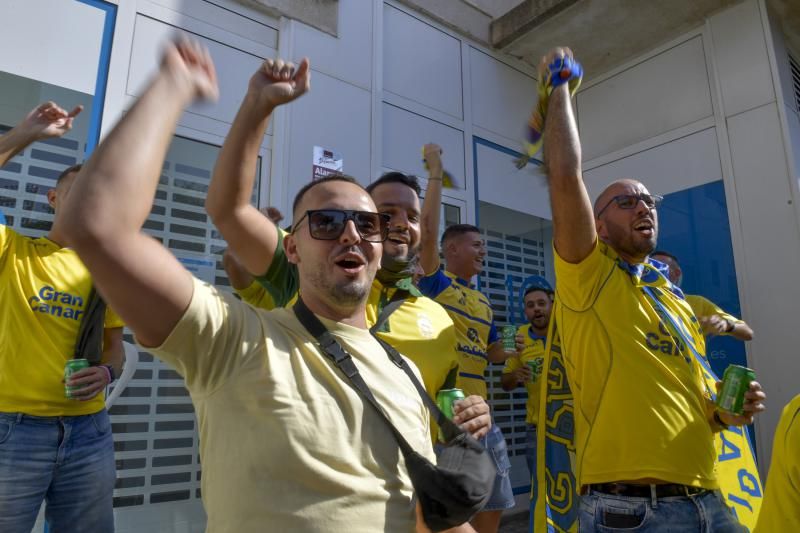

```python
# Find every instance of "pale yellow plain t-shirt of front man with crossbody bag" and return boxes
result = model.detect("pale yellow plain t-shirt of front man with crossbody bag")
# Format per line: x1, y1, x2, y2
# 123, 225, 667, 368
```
146, 280, 434, 533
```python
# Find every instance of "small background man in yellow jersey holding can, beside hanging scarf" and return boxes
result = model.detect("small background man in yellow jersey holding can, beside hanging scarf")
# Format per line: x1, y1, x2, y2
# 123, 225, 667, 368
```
500, 285, 553, 478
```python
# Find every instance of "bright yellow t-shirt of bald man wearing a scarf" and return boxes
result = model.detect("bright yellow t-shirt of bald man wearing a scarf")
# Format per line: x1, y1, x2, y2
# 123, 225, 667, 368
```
553, 243, 717, 489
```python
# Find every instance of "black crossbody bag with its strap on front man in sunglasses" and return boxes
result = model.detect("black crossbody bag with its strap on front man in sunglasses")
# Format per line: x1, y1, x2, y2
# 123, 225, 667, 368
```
293, 298, 497, 531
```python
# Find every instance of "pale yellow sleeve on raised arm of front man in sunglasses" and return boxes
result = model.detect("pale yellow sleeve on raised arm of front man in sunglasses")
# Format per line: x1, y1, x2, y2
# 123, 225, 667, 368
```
143, 278, 266, 394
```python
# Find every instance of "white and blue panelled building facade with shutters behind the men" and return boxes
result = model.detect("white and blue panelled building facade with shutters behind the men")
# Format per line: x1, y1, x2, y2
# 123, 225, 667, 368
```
0, 0, 800, 533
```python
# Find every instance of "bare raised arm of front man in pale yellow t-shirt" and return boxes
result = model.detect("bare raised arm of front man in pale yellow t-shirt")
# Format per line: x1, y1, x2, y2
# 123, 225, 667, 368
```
64, 40, 217, 346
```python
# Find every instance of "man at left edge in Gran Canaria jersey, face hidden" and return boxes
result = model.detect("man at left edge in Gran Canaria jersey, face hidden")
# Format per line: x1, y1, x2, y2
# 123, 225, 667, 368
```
0, 102, 123, 533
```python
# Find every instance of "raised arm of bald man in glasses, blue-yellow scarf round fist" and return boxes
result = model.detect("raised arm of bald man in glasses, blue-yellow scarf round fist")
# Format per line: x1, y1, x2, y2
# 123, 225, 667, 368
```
539, 48, 597, 263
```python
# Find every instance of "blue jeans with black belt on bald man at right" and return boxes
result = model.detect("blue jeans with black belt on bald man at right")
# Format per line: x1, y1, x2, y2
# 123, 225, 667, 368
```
580, 490, 747, 533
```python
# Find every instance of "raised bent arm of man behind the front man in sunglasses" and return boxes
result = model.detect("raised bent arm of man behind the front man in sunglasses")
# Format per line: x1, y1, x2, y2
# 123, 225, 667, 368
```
206, 59, 311, 275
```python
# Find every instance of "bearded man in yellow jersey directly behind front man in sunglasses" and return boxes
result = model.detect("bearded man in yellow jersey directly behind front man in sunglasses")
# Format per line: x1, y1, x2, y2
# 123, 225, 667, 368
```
206, 60, 490, 438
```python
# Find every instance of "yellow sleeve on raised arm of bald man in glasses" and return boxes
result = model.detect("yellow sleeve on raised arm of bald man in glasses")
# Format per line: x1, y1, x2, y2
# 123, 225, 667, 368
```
553, 240, 617, 311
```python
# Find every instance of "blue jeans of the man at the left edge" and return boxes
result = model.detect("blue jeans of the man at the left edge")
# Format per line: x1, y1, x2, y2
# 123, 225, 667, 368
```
0, 409, 116, 533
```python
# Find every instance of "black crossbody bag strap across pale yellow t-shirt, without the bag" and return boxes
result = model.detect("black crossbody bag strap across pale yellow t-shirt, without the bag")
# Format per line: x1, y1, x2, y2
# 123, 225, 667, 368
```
292, 297, 464, 448
